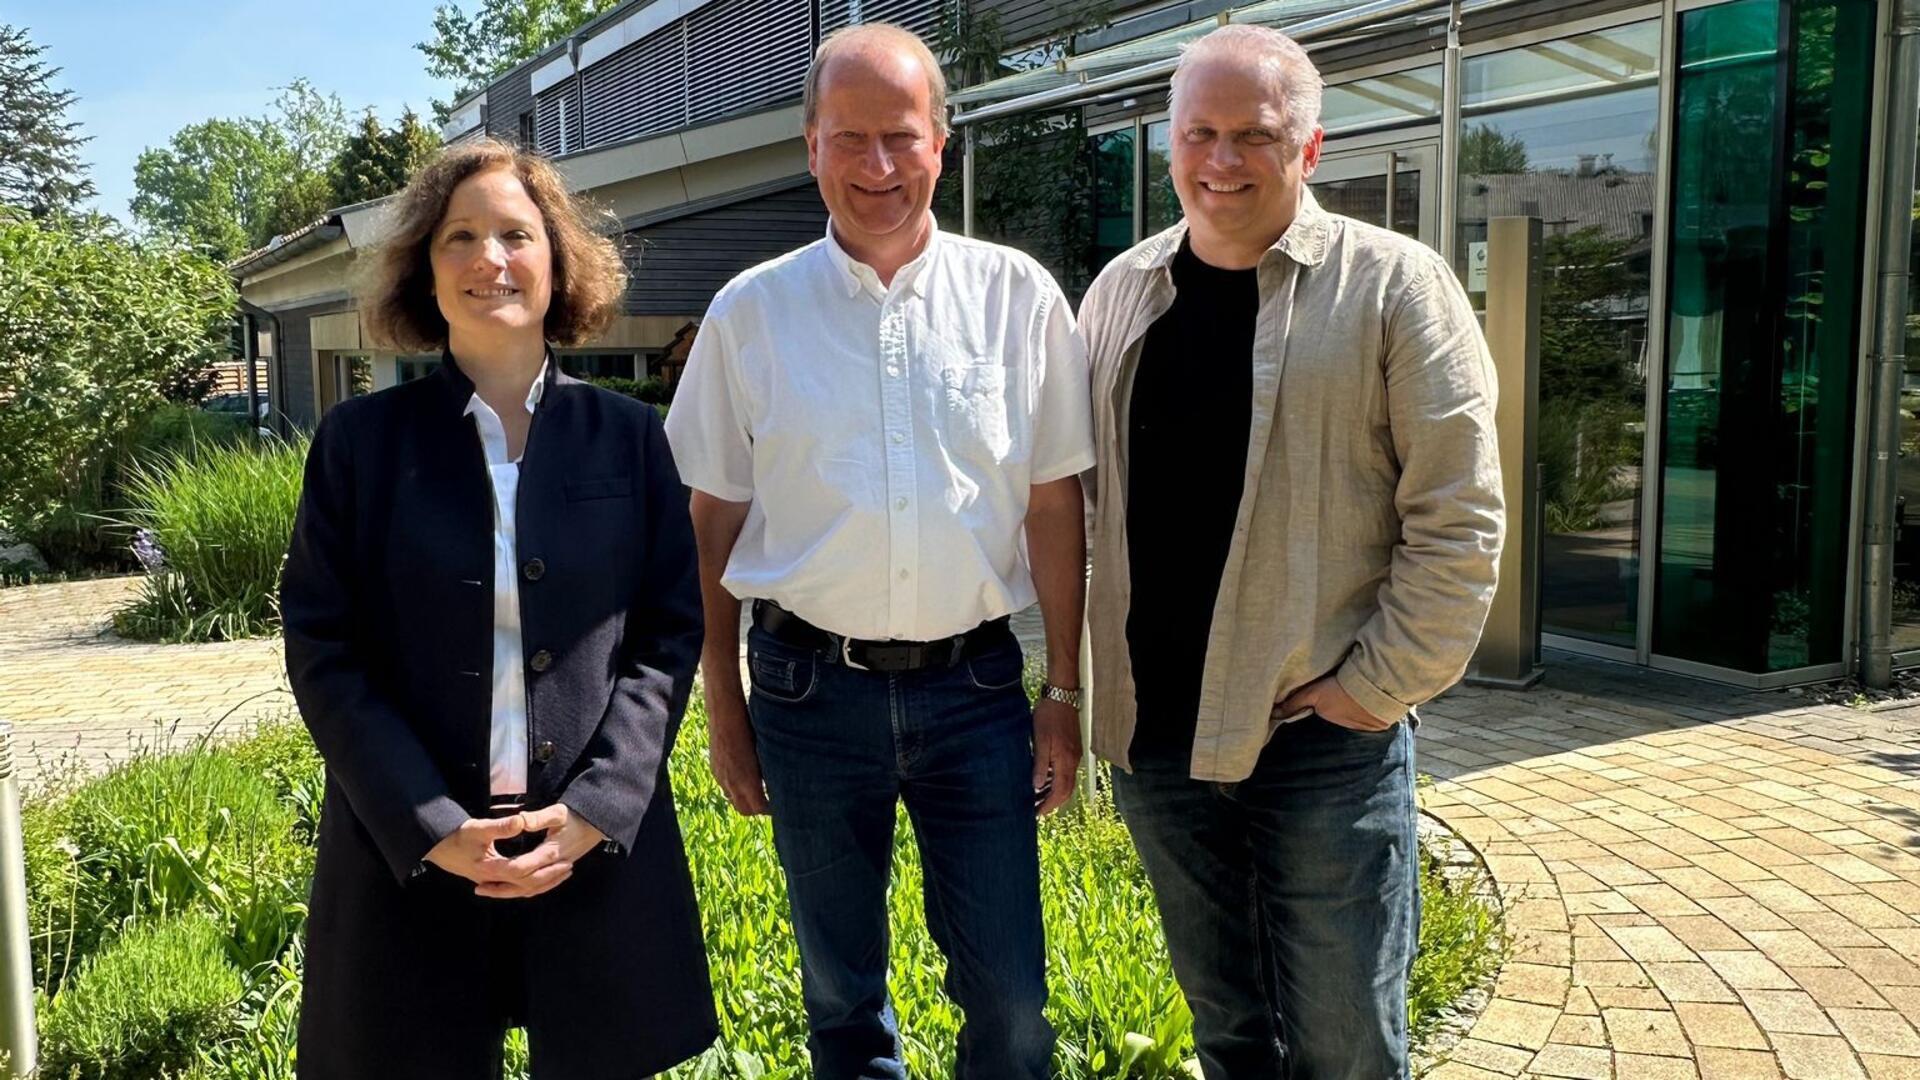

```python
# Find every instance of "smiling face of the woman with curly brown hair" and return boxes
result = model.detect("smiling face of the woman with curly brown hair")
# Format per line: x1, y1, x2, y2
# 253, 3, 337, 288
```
430, 169, 553, 344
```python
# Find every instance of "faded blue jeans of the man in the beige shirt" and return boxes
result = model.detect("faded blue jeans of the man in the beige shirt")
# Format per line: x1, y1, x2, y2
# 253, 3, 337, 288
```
1114, 717, 1419, 1080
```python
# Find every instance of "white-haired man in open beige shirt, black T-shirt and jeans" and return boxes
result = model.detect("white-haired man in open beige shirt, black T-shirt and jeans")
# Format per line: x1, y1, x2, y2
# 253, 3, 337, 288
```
1081, 27, 1505, 1080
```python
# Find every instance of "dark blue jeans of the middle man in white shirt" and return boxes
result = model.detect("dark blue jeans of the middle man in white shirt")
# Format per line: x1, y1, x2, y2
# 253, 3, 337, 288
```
747, 628, 1054, 1080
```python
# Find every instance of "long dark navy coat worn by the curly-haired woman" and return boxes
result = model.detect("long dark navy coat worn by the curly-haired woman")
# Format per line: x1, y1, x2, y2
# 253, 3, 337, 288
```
280, 357, 716, 1076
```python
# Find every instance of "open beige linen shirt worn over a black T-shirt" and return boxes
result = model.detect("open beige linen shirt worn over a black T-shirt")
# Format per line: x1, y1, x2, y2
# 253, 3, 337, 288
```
1081, 194, 1505, 782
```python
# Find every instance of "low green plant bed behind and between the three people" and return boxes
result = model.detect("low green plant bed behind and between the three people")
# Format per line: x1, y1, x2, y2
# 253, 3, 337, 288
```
25, 703, 1500, 1080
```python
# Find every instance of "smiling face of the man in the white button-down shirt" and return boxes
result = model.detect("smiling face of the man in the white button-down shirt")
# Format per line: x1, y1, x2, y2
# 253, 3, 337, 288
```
806, 42, 947, 261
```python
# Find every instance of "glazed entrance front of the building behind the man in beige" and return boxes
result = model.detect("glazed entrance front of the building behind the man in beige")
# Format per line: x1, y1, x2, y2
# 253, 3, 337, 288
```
956, 0, 1920, 686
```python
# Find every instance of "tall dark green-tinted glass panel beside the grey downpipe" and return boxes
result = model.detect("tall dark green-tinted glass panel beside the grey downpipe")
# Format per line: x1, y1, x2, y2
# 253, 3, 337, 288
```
1653, 0, 1874, 673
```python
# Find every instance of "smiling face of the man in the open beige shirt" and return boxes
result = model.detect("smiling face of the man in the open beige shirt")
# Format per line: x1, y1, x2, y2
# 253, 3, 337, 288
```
1169, 54, 1321, 258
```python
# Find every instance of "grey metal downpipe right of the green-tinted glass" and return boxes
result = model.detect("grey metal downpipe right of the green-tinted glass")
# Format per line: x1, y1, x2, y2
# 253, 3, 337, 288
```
1860, 0, 1920, 688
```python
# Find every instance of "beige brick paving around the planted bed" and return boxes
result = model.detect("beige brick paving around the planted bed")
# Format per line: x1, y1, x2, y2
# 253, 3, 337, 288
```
0, 578, 1920, 1080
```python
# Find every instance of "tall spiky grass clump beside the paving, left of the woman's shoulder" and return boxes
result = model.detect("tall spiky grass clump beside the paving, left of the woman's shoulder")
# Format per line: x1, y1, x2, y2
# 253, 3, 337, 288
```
113, 432, 307, 642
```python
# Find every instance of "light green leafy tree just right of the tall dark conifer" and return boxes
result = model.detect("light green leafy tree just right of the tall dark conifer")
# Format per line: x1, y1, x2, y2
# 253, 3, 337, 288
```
132, 79, 348, 261
